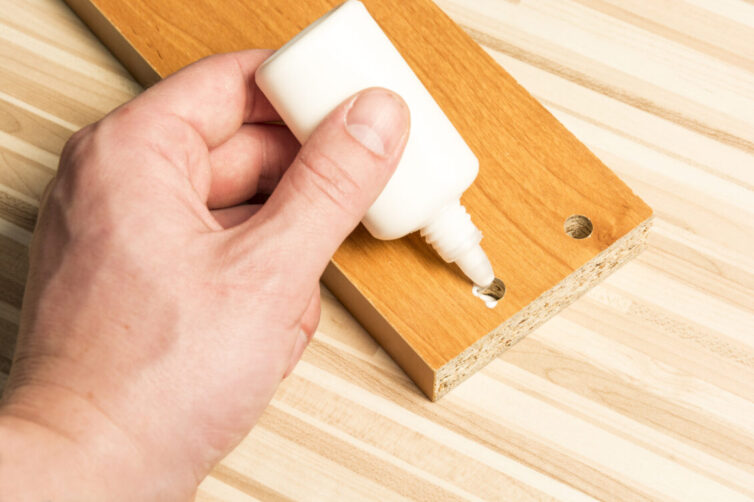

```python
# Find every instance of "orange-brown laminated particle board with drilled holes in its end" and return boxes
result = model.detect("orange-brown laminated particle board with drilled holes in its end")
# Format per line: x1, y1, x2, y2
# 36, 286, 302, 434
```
66, 0, 652, 400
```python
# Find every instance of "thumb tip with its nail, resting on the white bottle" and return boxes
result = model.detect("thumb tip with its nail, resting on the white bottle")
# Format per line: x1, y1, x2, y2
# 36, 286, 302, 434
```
346, 89, 409, 157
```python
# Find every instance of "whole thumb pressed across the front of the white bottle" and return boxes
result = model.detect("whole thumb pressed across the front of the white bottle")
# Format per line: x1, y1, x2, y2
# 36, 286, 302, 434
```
247, 88, 409, 280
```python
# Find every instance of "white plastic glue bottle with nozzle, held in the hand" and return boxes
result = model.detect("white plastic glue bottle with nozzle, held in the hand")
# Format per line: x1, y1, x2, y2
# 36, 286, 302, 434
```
256, 0, 495, 286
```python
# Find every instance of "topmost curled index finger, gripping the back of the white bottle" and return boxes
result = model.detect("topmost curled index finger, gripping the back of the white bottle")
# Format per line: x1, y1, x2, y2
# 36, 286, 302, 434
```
128, 49, 280, 148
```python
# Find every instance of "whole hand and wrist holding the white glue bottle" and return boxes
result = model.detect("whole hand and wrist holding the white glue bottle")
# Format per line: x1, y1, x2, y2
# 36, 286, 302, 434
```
0, 50, 409, 501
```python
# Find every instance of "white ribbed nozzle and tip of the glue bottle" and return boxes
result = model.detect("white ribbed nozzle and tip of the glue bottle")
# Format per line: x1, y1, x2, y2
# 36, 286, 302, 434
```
421, 201, 495, 286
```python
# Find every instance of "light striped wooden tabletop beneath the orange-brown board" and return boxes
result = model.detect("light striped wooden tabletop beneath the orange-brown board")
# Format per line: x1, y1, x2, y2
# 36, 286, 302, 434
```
0, 0, 754, 501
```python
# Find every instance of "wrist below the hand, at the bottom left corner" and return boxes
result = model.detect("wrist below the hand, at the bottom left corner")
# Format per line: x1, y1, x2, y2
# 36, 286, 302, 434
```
0, 387, 195, 501
